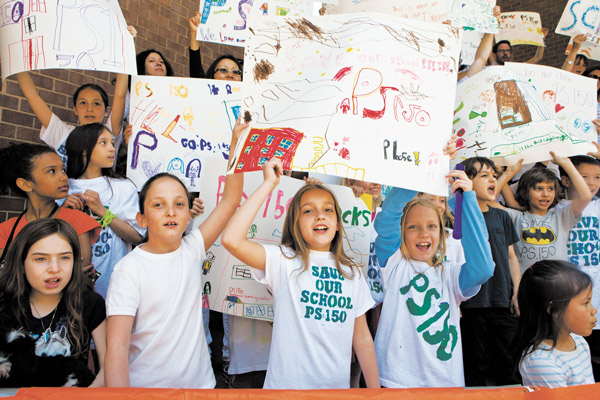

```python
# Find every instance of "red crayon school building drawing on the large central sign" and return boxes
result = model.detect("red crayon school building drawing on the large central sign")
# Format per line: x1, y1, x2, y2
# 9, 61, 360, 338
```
235, 128, 304, 172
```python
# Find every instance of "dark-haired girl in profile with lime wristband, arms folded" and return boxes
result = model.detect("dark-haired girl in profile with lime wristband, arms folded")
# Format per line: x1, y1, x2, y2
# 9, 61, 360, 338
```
63, 122, 144, 297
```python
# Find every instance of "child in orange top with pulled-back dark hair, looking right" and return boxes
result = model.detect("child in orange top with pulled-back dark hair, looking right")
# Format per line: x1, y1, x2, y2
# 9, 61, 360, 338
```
0, 143, 100, 266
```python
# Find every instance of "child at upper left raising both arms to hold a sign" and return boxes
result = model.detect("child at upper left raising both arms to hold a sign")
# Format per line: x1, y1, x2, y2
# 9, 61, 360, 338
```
17, 72, 128, 163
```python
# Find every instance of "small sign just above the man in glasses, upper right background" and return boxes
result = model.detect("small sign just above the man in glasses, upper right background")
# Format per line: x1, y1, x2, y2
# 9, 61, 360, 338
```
496, 12, 544, 46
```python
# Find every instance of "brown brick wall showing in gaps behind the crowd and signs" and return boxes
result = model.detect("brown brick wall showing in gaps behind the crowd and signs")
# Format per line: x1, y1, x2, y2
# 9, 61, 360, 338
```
0, 0, 598, 221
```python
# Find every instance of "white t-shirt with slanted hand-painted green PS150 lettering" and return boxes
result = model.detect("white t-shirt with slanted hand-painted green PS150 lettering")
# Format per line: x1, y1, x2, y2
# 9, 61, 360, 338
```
375, 250, 479, 388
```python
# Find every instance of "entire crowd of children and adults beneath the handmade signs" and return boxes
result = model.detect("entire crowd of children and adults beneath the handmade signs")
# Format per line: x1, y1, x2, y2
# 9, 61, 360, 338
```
0, 3, 600, 389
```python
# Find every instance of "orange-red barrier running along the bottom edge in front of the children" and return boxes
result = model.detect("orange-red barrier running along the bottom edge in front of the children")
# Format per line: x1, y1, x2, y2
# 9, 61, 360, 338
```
10, 383, 600, 400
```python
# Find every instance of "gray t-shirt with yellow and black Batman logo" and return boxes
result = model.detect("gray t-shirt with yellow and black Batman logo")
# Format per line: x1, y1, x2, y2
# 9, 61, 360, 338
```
506, 207, 581, 274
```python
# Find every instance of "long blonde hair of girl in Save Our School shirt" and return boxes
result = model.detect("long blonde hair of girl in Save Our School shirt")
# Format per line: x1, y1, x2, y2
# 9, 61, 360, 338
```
281, 184, 360, 279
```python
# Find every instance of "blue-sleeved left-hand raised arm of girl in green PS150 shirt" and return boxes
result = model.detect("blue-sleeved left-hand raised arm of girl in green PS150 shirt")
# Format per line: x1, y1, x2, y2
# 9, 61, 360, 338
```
375, 187, 417, 268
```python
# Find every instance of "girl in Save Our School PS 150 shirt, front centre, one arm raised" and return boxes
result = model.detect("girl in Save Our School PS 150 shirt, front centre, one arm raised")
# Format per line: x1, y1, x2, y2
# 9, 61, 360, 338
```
222, 158, 379, 389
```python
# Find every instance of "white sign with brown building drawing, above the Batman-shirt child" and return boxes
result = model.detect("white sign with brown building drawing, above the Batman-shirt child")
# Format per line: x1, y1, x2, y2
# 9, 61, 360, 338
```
454, 63, 595, 165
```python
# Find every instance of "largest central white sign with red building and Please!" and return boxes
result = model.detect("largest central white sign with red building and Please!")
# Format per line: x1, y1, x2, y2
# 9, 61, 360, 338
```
232, 13, 460, 195
